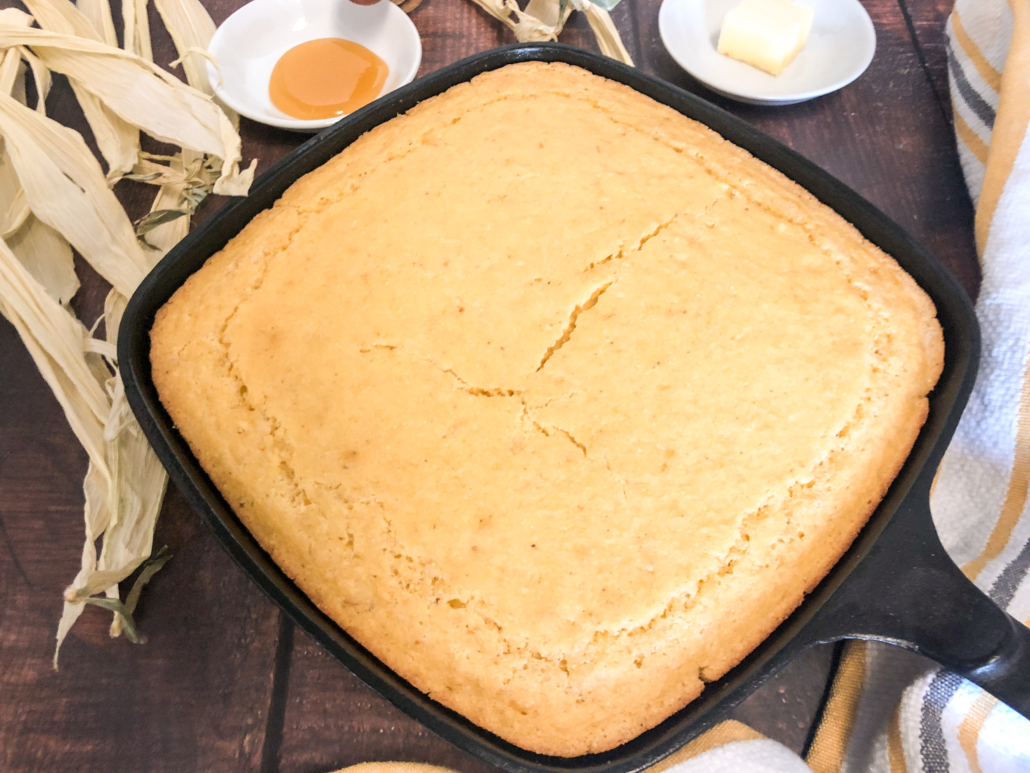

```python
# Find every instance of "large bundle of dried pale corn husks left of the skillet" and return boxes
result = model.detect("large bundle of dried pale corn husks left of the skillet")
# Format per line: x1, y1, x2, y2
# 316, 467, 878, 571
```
0, 0, 253, 667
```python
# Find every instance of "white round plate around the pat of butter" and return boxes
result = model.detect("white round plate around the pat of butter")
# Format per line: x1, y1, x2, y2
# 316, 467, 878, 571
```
658, 0, 877, 105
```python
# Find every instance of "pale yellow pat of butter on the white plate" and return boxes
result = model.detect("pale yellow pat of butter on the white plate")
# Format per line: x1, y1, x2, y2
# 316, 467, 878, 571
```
719, 0, 815, 75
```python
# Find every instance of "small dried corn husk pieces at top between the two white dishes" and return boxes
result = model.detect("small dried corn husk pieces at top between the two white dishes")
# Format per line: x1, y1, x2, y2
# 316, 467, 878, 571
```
472, 0, 633, 65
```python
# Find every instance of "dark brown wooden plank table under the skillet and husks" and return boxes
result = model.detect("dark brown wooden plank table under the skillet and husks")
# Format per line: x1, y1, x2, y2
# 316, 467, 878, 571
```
0, 0, 979, 773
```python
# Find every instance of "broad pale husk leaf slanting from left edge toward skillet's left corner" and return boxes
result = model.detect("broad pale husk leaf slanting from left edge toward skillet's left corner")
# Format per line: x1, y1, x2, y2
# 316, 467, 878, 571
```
0, 87, 150, 296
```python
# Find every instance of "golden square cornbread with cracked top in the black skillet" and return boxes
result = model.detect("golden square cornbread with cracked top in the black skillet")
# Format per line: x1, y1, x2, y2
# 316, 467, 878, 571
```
151, 63, 942, 755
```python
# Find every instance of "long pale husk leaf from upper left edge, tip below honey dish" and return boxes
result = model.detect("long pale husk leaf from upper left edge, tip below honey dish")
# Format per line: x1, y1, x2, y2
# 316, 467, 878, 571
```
0, 25, 253, 196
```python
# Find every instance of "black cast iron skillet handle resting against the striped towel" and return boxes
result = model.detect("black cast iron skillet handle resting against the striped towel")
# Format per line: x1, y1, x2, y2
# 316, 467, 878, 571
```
810, 488, 1030, 718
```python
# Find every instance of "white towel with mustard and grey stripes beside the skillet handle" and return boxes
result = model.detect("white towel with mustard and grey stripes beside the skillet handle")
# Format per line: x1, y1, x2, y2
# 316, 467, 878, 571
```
659, 0, 1030, 773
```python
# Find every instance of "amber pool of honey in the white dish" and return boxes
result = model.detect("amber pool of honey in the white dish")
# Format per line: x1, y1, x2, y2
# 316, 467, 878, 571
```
268, 37, 389, 121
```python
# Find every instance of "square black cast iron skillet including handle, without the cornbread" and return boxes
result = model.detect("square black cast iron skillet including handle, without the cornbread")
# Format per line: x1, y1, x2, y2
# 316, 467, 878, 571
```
118, 44, 1030, 773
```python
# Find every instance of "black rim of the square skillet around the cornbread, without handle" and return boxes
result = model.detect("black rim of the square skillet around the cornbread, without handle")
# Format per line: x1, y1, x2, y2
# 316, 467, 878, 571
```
118, 43, 980, 773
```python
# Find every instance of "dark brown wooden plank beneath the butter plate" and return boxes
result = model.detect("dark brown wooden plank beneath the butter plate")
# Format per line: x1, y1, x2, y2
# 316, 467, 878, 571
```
627, 0, 980, 294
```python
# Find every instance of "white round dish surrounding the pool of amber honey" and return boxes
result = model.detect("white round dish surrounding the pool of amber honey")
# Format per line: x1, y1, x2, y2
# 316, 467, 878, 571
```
207, 0, 422, 132
